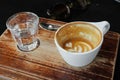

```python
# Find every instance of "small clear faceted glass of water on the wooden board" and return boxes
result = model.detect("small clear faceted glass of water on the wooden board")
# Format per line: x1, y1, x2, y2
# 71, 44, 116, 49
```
6, 12, 40, 51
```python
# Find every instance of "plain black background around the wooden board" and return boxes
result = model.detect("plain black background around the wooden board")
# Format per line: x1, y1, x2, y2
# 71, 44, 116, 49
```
0, 0, 120, 80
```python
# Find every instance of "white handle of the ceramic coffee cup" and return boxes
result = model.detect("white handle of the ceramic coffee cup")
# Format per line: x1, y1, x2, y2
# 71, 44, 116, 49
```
92, 21, 110, 35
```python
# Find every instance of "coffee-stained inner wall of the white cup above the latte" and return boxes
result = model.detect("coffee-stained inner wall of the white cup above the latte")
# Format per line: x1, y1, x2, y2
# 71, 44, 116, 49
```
55, 22, 102, 52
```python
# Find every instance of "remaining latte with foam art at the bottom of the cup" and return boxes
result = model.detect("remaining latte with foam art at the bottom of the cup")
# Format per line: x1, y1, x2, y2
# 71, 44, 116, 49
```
63, 38, 94, 52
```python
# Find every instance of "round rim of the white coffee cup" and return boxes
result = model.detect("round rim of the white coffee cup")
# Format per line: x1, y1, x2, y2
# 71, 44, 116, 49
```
54, 21, 103, 55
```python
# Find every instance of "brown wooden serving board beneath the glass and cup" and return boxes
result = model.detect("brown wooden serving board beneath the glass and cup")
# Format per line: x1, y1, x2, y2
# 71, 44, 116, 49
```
0, 18, 120, 80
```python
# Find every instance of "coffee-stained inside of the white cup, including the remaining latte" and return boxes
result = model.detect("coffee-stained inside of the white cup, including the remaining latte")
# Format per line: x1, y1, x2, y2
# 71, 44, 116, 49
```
57, 22, 102, 52
